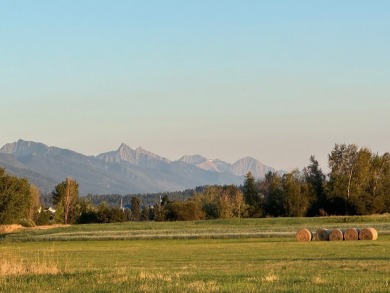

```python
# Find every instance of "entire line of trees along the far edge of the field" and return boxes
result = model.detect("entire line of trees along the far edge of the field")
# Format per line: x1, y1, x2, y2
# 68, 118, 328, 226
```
0, 144, 390, 226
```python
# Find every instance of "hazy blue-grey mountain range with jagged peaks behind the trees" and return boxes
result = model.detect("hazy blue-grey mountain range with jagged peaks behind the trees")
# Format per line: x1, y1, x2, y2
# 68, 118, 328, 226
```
0, 140, 282, 194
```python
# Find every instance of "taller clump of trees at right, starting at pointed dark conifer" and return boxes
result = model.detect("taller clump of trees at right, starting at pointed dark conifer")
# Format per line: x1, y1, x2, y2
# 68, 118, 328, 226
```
244, 144, 390, 217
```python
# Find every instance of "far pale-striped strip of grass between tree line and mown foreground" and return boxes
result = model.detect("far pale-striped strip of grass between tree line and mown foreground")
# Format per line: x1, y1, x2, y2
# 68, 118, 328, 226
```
0, 215, 390, 241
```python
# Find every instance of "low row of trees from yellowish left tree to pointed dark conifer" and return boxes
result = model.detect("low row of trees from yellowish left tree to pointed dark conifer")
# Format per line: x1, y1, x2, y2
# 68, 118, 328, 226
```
48, 184, 247, 224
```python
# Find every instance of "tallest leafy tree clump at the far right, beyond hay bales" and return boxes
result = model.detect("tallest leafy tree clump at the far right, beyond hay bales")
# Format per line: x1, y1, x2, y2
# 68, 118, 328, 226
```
328, 144, 390, 214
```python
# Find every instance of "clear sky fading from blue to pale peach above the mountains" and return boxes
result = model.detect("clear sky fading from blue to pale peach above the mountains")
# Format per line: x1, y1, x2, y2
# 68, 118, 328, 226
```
0, 0, 390, 171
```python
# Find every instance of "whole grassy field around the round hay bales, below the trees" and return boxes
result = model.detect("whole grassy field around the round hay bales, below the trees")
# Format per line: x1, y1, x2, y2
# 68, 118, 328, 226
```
0, 216, 390, 292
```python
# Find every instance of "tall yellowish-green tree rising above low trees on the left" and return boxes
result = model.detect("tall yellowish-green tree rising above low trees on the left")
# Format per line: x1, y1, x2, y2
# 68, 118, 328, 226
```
52, 177, 80, 224
